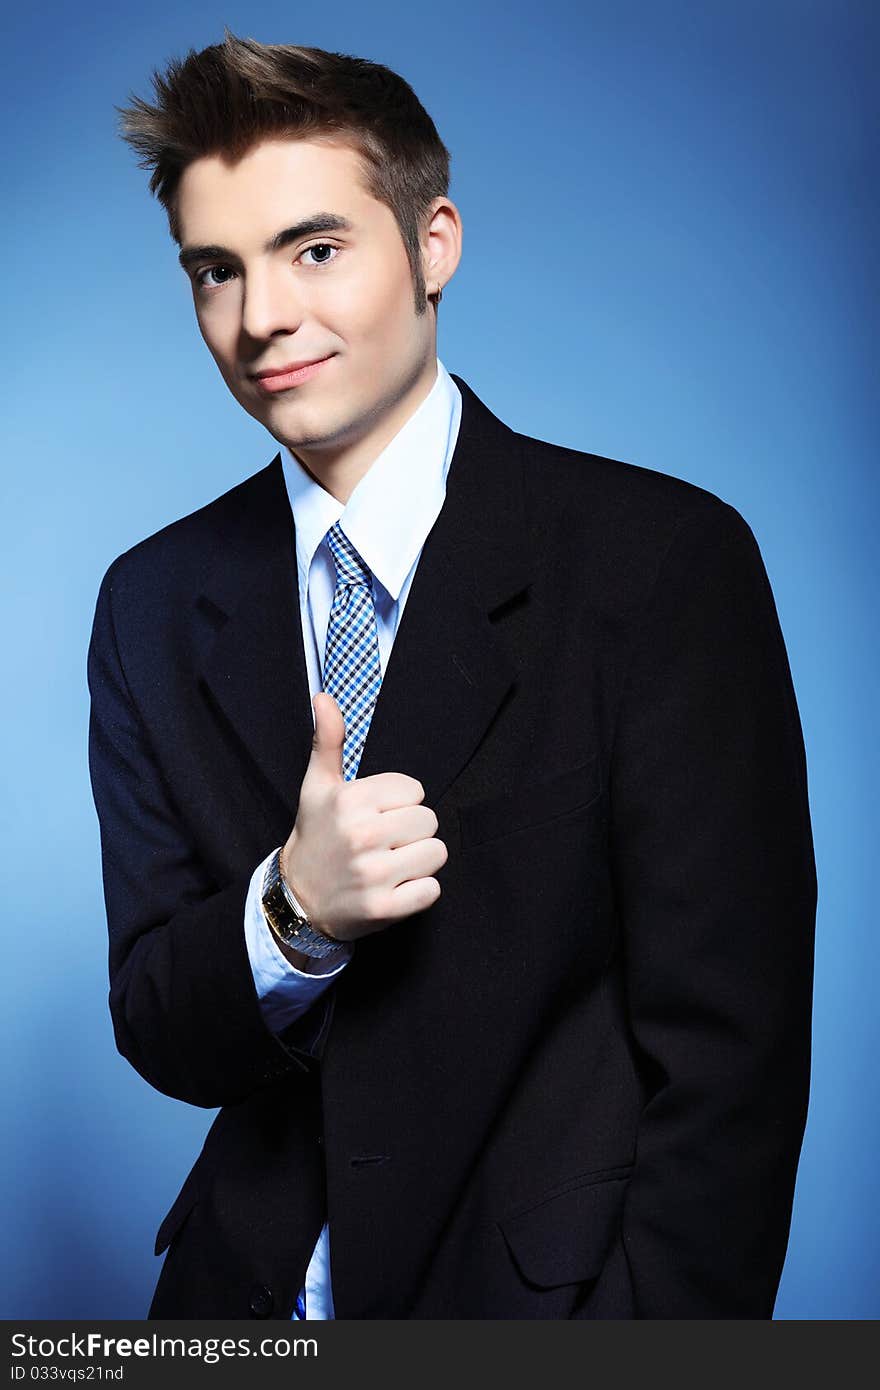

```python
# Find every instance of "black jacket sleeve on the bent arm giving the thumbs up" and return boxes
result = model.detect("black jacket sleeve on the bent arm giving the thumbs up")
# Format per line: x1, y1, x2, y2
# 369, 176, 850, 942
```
88, 560, 329, 1108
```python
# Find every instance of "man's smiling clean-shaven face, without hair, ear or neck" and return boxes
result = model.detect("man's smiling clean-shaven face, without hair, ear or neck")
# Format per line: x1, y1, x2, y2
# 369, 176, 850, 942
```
178, 139, 437, 463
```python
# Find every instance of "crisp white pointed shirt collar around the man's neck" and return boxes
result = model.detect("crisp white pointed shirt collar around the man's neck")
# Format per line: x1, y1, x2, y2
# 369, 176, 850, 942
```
281, 359, 462, 600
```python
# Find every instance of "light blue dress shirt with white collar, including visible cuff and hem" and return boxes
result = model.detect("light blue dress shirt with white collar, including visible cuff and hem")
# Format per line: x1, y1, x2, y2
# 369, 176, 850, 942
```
245, 359, 462, 1319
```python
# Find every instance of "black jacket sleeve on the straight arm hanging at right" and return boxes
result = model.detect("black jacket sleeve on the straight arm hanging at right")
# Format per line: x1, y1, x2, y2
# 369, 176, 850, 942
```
585, 503, 816, 1318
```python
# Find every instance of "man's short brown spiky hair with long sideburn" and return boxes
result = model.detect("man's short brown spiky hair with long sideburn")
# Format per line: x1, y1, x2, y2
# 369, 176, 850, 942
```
115, 25, 449, 314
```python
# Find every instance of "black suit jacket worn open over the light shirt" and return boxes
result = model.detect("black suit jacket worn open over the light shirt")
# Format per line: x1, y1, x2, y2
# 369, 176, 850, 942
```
89, 377, 816, 1318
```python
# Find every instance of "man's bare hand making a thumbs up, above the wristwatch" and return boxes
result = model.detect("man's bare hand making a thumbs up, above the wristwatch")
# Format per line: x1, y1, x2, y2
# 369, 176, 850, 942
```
281, 692, 448, 941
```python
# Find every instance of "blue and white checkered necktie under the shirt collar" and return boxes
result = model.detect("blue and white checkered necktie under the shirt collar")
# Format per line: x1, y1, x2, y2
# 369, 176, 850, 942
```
293, 521, 382, 1319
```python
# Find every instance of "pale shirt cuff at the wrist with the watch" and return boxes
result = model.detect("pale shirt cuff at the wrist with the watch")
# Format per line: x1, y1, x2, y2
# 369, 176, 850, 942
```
245, 849, 353, 1033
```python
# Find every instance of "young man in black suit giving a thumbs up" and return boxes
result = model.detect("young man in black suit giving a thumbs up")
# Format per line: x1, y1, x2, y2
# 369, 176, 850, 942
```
89, 33, 816, 1318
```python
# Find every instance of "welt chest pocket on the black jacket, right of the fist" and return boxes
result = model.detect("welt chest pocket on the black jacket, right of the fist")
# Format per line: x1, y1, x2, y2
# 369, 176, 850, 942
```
459, 753, 602, 849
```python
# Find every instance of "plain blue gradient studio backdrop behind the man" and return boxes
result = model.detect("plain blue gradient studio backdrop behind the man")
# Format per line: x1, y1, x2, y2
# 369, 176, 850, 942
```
0, 0, 880, 1319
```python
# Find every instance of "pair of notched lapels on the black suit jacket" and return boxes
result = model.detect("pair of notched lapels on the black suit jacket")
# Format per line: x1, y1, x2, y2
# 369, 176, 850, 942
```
199, 377, 530, 819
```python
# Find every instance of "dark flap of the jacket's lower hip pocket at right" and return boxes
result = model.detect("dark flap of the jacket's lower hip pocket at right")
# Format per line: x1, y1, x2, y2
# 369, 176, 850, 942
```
498, 1163, 633, 1289
